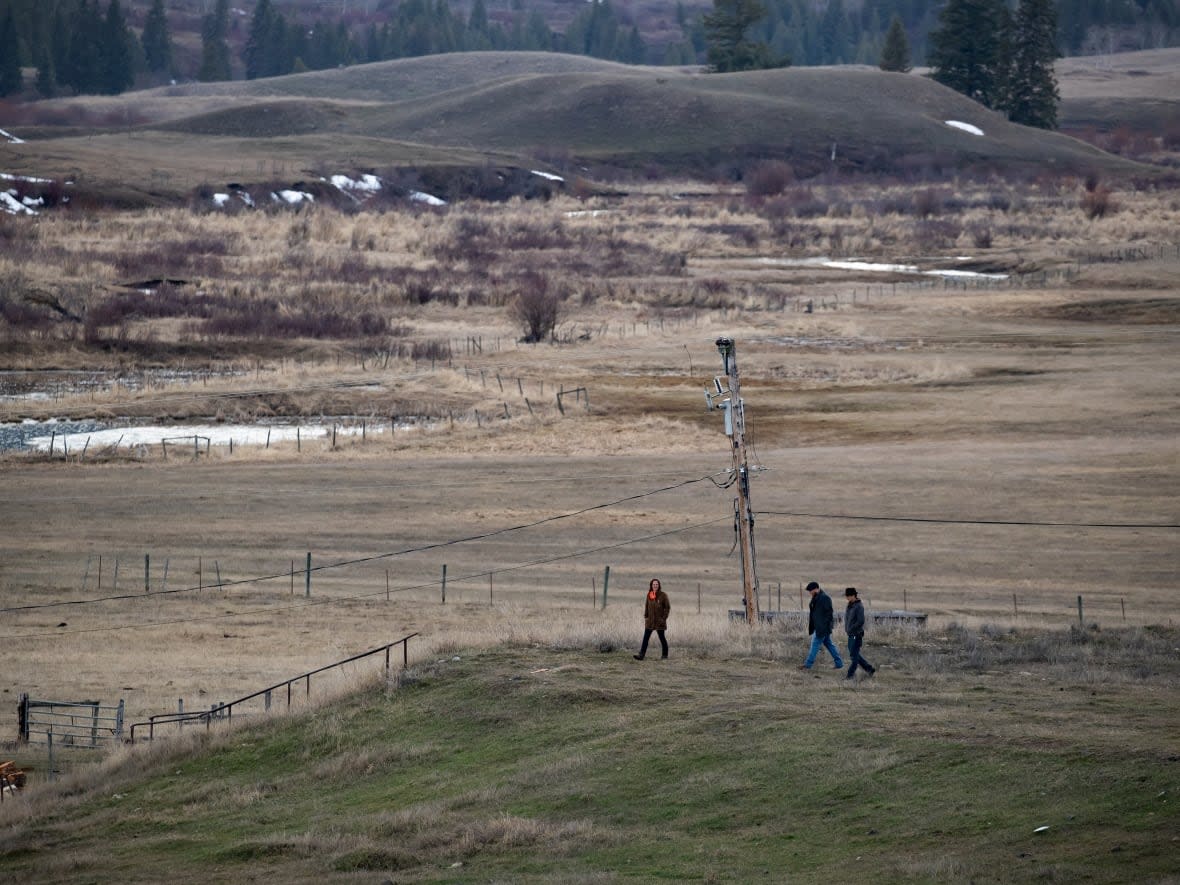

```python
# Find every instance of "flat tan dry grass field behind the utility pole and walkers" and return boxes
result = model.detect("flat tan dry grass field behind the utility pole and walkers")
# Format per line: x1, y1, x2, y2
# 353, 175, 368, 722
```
0, 182, 1180, 755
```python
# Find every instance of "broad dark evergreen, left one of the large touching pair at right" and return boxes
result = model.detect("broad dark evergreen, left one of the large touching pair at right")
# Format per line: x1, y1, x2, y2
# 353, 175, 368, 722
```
926, 0, 1007, 107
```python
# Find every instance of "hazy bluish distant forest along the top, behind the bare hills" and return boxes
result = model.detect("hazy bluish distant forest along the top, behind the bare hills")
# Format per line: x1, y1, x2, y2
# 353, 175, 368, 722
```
0, 0, 1180, 96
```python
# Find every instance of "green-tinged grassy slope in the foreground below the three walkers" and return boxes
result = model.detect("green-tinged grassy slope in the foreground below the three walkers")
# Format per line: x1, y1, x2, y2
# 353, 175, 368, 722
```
0, 628, 1180, 883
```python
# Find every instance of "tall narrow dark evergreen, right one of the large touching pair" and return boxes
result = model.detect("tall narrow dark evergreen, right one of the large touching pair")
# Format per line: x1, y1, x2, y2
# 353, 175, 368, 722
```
1004, 0, 1061, 129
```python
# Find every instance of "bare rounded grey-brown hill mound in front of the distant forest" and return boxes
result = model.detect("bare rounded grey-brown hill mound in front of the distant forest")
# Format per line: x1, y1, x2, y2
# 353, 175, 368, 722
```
0, 53, 1151, 210
